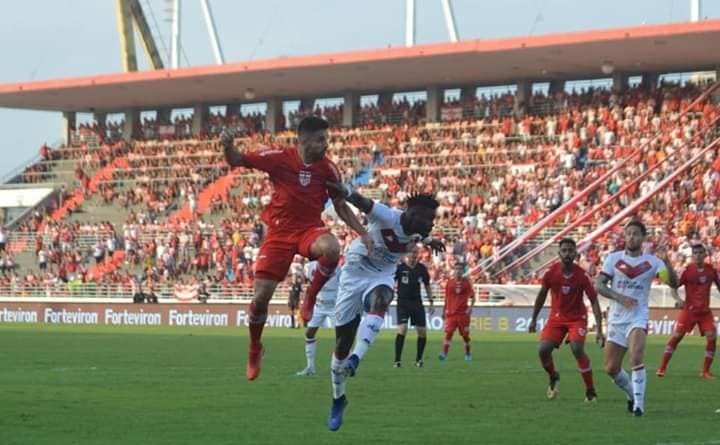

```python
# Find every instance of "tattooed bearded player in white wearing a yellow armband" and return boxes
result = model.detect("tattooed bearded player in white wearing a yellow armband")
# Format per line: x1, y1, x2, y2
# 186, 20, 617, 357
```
595, 221, 678, 416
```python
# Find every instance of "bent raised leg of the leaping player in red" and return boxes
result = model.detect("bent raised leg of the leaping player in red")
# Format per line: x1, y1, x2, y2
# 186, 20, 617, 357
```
300, 228, 340, 322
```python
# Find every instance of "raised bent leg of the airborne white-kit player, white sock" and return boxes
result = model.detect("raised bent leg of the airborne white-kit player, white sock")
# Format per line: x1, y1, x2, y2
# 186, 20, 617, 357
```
345, 285, 394, 376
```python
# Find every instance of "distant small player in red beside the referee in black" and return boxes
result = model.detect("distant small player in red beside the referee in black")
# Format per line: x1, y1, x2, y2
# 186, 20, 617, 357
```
438, 262, 475, 361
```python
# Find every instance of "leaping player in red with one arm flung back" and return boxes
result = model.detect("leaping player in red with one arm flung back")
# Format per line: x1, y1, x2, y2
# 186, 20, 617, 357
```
220, 116, 373, 380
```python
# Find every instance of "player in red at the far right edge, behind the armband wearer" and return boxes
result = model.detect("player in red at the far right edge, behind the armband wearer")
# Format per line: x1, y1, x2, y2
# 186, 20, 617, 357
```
656, 244, 720, 379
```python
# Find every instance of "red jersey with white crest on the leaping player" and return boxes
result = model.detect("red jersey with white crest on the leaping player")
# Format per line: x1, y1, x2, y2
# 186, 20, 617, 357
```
243, 148, 341, 231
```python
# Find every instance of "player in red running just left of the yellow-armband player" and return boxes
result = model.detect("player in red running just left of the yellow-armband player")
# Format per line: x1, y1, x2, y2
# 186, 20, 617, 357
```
528, 238, 605, 402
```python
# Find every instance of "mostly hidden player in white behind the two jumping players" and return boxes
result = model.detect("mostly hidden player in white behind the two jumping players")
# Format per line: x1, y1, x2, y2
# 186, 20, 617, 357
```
295, 261, 341, 376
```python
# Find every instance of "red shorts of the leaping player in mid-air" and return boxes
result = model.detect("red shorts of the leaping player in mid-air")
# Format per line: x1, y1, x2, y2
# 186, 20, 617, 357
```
255, 227, 330, 281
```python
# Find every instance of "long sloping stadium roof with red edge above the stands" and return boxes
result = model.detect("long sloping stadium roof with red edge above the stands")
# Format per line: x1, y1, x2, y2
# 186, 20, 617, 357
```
0, 20, 720, 111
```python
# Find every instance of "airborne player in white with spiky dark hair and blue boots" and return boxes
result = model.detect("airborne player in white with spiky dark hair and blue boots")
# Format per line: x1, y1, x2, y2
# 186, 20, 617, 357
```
328, 183, 445, 431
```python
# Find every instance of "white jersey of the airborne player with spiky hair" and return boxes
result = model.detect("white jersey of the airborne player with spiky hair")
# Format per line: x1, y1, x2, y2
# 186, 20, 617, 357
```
345, 202, 422, 276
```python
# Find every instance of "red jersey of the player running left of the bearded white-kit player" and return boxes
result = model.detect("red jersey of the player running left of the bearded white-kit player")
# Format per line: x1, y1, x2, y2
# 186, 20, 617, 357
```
542, 263, 597, 320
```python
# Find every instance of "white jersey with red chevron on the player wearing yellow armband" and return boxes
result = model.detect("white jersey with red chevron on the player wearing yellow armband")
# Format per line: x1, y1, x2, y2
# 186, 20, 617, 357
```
601, 251, 666, 323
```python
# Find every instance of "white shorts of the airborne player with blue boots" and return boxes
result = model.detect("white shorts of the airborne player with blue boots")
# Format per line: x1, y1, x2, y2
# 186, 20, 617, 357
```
335, 265, 395, 326
